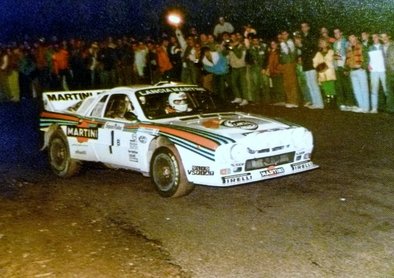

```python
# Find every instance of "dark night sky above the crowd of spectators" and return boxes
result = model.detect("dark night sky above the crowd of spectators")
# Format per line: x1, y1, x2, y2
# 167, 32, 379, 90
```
0, 0, 394, 42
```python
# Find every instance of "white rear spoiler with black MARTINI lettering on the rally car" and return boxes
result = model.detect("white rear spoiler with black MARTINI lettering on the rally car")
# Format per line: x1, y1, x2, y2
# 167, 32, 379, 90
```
42, 90, 108, 112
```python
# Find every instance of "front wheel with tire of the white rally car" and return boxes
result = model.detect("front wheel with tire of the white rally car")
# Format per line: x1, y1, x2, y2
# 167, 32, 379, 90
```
150, 146, 194, 198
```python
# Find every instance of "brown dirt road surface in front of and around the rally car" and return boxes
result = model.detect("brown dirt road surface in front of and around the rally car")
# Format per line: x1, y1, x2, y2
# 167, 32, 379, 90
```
0, 103, 394, 277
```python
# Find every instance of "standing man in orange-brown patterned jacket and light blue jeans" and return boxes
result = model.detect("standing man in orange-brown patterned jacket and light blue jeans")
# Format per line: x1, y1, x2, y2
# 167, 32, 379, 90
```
346, 34, 369, 113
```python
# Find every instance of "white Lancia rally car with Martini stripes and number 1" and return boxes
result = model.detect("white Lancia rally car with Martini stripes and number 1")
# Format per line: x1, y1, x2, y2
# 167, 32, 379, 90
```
40, 83, 318, 197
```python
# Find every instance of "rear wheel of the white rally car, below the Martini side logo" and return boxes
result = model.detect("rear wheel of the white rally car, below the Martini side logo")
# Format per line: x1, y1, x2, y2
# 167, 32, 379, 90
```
48, 130, 81, 178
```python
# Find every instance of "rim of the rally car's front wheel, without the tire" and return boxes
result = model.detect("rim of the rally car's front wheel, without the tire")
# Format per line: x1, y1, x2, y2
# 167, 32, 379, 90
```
153, 154, 176, 191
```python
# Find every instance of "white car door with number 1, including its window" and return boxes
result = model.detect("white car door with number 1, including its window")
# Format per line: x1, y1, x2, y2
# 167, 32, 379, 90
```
93, 93, 139, 169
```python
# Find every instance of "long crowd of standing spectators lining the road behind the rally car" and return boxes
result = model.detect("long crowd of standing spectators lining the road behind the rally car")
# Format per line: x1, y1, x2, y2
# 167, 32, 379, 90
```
0, 17, 394, 113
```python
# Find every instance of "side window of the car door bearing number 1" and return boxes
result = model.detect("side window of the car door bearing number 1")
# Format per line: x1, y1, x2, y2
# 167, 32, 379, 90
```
104, 94, 134, 120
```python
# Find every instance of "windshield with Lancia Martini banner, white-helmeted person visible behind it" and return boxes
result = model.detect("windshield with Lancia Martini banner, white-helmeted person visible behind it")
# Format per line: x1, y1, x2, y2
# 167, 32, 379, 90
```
137, 86, 225, 119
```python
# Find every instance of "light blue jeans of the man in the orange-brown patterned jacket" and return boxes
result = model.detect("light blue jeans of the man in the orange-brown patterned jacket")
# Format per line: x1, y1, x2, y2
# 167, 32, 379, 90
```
350, 69, 369, 111
